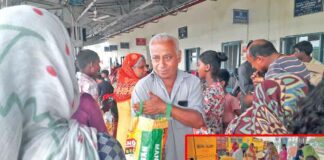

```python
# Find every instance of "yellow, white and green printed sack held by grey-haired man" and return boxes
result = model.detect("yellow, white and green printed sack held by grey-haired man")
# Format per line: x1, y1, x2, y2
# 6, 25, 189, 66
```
125, 103, 170, 160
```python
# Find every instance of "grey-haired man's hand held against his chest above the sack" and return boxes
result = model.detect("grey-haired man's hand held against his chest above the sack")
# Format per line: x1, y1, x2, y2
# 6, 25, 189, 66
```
133, 92, 166, 115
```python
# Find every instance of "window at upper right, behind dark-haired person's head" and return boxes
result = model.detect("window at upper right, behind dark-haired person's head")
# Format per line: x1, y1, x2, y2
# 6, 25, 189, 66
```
280, 33, 324, 62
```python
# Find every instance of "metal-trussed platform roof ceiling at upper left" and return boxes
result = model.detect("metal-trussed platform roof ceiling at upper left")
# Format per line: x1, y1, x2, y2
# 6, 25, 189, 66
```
0, 0, 204, 45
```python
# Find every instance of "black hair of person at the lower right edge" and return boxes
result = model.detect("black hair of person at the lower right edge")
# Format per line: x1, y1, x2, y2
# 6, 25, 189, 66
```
289, 80, 324, 134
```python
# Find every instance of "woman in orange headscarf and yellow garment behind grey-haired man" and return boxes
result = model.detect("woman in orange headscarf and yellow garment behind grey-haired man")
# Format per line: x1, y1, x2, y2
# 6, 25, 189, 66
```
114, 53, 147, 150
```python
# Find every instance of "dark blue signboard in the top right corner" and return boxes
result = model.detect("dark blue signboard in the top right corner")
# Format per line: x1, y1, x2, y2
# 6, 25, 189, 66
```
294, 0, 323, 17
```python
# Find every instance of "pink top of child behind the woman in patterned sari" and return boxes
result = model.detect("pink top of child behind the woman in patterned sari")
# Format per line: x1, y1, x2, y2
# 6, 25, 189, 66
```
223, 93, 241, 124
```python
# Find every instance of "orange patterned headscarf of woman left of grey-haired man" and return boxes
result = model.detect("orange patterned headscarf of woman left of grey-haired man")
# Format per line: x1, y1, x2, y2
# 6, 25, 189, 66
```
115, 53, 143, 102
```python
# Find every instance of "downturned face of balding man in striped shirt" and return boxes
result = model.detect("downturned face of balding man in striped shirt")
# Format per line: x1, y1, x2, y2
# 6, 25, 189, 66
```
246, 53, 268, 73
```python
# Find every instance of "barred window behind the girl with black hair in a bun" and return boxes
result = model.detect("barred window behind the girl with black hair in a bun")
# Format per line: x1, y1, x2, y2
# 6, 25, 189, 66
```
222, 41, 241, 71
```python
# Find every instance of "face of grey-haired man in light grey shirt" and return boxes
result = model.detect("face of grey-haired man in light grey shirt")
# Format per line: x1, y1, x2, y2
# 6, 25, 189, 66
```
150, 40, 181, 79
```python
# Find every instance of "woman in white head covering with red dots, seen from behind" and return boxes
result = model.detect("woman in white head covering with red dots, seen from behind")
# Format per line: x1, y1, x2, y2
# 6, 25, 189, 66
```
0, 6, 124, 160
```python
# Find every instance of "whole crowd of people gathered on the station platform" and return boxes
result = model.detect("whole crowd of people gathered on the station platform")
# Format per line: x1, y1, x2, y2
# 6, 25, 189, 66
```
0, 6, 324, 159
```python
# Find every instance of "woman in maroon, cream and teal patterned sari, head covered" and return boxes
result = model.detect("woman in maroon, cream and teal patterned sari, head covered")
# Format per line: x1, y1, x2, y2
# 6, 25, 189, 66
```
226, 73, 308, 134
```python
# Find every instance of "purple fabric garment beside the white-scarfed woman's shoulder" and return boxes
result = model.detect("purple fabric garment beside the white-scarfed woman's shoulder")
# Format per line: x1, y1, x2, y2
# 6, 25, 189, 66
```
72, 93, 107, 133
